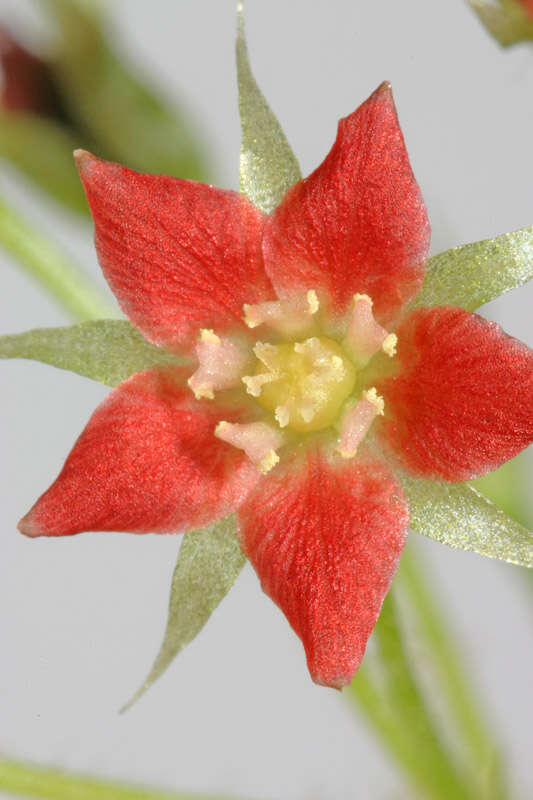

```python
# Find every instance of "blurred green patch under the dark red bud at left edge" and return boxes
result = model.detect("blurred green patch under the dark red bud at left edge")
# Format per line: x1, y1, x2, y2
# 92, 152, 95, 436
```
0, 111, 89, 215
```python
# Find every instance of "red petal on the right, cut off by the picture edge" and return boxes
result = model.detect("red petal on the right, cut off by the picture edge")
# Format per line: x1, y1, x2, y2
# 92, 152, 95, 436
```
377, 306, 533, 481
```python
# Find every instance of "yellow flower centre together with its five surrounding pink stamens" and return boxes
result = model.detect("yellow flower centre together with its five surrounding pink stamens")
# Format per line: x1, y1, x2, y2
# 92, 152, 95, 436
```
201, 289, 397, 472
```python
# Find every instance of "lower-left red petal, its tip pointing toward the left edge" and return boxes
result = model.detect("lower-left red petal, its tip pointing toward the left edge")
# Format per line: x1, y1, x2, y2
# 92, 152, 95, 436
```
19, 370, 259, 536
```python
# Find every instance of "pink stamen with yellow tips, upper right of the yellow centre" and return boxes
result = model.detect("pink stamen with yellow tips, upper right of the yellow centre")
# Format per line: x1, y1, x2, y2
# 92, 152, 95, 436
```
344, 294, 398, 369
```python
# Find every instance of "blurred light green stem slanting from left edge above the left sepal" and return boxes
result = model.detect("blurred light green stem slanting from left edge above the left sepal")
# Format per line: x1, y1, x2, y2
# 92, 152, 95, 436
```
0, 198, 118, 320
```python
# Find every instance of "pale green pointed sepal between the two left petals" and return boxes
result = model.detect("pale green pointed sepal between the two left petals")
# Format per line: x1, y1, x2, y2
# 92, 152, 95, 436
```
0, 319, 183, 386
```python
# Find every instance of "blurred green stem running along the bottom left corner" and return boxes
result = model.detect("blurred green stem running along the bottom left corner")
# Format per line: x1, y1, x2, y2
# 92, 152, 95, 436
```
0, 758, 235, 800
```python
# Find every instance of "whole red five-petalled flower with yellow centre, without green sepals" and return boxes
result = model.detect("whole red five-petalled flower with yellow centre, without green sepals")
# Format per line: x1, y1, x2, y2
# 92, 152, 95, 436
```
16, 84, 533, 687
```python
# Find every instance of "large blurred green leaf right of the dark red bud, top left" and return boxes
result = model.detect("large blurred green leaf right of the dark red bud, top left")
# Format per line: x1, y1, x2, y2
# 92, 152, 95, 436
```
40, 0, 207, 180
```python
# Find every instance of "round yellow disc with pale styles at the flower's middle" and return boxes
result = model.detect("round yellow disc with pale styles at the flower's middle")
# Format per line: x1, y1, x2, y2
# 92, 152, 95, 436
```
253, 336, 355, 432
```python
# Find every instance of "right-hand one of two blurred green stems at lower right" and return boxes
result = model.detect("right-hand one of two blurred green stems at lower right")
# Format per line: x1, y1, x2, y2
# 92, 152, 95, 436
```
397, 549, 507, 799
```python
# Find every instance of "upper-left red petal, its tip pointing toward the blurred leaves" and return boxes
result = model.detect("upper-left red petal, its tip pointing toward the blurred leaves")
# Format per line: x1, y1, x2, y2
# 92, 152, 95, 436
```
78, 151, 274, 349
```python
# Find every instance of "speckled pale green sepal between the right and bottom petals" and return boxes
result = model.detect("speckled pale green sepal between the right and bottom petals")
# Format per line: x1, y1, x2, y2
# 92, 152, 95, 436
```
402, 475, 533, 567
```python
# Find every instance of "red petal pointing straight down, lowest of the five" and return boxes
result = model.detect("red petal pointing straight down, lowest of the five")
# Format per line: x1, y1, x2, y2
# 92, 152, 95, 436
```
239, 451, 409, 689
